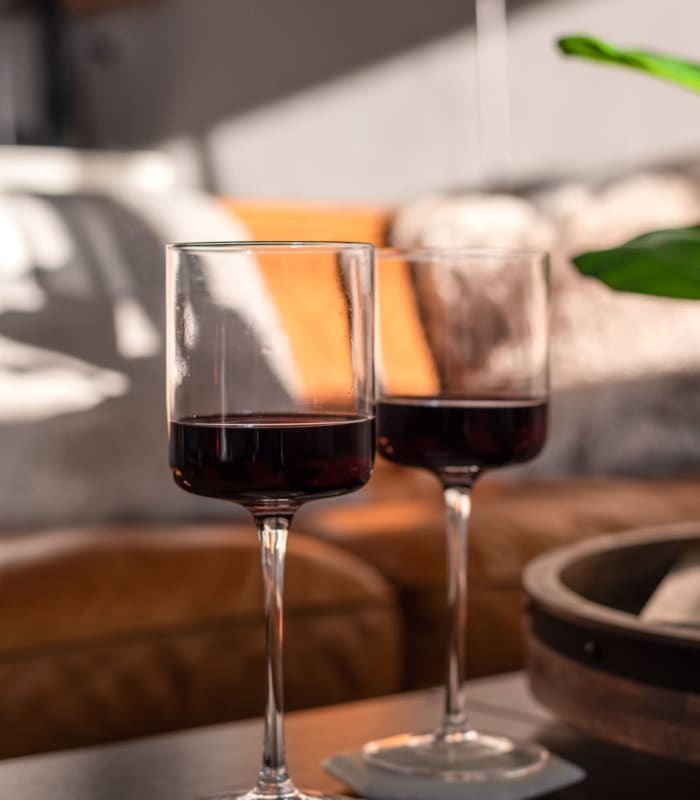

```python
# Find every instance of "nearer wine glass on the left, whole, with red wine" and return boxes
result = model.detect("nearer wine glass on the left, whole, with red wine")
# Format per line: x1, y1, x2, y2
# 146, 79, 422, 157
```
167, 242, 374, 800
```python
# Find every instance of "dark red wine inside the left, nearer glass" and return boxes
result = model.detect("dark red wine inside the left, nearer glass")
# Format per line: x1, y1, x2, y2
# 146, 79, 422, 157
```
170, 414, 374, 507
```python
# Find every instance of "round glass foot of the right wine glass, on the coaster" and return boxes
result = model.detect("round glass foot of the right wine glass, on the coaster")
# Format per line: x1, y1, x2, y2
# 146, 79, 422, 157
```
362, 731, 549, 783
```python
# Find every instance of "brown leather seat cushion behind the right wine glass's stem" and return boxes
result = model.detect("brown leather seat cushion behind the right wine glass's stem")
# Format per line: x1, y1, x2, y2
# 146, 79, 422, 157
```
304, 466, 700, 688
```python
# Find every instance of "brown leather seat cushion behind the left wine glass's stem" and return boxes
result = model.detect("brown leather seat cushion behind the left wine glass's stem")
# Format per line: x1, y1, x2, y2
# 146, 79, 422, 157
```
0, 525, 402, 757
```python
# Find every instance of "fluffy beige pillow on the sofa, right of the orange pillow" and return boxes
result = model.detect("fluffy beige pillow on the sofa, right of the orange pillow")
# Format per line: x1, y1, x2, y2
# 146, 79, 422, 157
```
392, 170, 700, 477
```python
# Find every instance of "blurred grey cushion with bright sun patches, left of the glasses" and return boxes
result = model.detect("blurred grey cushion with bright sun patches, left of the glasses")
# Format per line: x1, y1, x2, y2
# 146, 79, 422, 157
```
0, 184, 264, 531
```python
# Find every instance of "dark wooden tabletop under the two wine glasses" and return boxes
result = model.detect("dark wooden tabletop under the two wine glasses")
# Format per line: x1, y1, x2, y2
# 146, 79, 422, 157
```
0, 675, 700, 800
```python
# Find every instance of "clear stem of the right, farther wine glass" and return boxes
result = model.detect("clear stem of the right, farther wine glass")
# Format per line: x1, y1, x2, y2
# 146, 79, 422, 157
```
439, 485, 471, 737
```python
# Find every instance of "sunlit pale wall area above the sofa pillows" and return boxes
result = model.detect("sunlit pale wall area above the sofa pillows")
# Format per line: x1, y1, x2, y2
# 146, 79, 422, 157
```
205, 0, 700, 202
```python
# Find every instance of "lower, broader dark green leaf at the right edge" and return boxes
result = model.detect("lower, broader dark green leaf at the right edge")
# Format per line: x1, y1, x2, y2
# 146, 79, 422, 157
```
574, 225, 700, 300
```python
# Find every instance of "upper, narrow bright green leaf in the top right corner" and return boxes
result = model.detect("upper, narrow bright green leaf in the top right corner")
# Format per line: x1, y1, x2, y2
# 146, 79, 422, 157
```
557, 36, 700, 92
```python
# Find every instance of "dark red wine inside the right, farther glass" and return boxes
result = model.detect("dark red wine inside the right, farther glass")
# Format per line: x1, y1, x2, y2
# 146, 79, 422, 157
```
377, 397, 547, 472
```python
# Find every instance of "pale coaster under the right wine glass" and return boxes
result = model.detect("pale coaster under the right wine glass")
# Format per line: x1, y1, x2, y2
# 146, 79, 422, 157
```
323, 750, 586, 800
